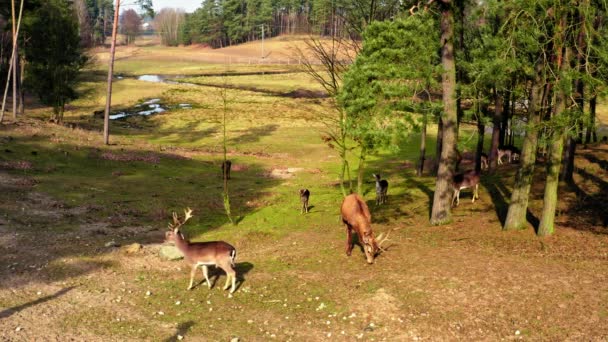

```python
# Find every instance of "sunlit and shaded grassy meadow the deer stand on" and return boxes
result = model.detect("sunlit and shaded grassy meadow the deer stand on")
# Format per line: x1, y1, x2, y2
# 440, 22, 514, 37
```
0, 39, 608, 341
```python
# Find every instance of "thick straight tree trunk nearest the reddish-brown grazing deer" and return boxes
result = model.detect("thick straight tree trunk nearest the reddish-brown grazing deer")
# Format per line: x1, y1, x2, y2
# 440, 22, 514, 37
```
430, 2, 458, 225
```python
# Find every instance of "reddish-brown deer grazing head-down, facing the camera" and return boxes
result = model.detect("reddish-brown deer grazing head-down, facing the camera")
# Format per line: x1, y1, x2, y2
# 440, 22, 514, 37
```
340, 194, 390, 264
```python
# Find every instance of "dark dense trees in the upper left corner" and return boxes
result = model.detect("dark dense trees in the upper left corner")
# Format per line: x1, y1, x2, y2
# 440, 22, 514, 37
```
0, 0, 87, 121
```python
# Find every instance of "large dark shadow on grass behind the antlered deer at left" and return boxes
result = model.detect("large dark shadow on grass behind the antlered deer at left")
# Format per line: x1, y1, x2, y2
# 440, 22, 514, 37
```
0, 126, 282, 288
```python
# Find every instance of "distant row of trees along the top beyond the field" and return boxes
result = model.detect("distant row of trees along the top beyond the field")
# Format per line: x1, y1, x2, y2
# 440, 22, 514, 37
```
180, 0, 400, 47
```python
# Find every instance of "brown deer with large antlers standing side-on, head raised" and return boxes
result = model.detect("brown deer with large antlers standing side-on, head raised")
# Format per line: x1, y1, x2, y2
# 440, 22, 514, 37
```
165, 208, 236, 294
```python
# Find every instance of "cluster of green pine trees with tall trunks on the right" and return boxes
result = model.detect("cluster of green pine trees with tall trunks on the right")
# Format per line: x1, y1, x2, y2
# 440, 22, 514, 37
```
316, 0, 608, 235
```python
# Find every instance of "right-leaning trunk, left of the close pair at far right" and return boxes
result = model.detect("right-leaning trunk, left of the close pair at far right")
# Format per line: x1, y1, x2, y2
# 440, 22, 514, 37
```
503, 60, 545, 230
